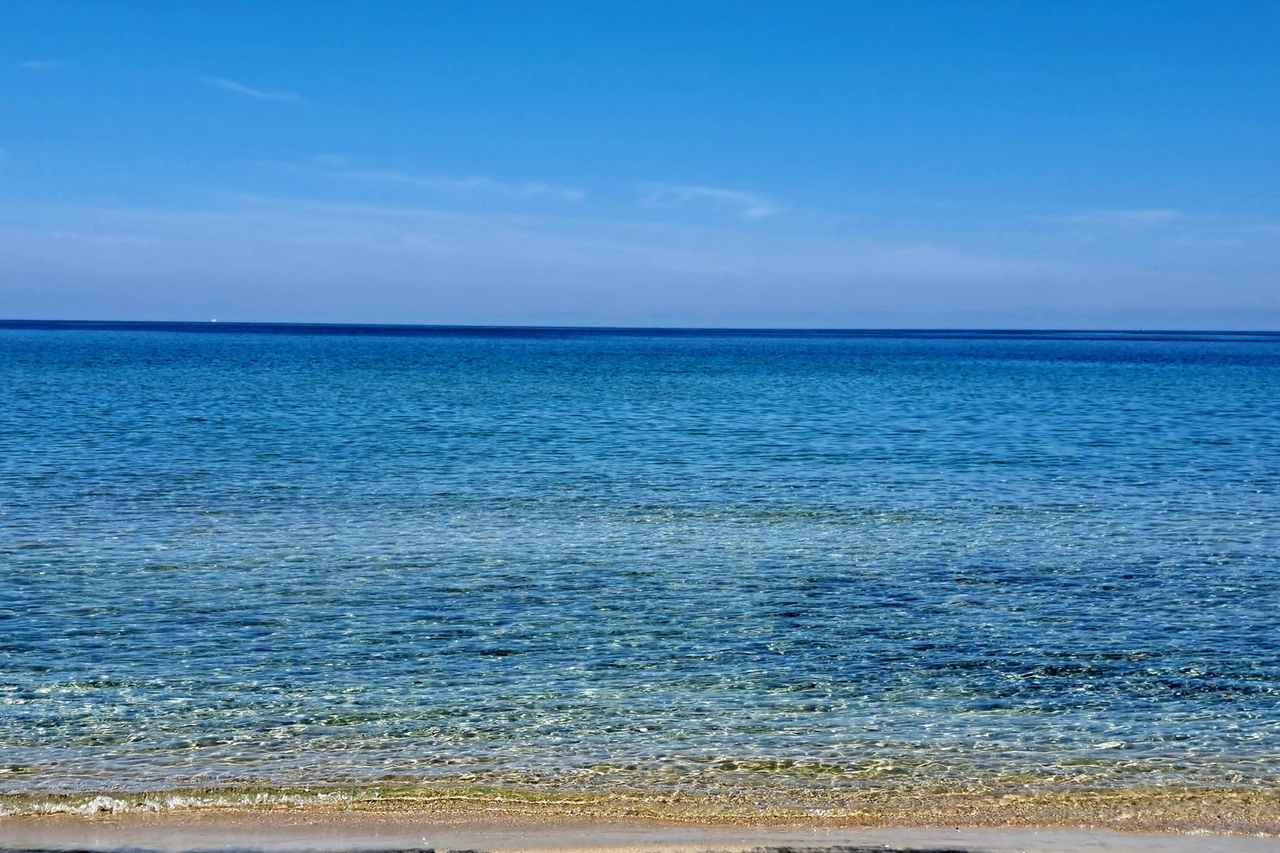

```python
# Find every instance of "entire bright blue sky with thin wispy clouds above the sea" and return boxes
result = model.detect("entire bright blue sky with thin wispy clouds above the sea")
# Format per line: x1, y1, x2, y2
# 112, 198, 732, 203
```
0, 0, 1280, 329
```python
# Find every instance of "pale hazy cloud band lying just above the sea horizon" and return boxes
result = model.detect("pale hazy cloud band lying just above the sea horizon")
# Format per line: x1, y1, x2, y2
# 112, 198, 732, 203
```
17, 196, 1280, 327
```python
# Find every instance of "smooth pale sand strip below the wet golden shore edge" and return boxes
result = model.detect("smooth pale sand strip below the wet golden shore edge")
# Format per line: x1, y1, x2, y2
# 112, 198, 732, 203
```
0, 812, 1280, 853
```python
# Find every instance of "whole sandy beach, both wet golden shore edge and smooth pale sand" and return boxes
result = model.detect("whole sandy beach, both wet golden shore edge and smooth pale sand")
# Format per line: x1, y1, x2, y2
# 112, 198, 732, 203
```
0, 788, 1280, 853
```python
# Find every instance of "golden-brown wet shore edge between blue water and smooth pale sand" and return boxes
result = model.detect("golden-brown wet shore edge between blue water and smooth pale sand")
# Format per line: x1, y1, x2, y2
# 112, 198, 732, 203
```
0, 784, 1280, 835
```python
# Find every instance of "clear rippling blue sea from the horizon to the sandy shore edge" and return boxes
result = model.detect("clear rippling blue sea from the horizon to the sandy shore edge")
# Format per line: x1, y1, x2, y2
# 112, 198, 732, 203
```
0, 324, 1280, 793
